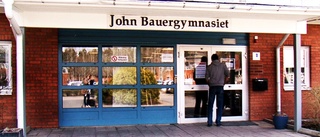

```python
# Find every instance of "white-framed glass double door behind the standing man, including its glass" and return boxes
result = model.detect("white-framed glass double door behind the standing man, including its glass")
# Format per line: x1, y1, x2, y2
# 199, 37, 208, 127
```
178, 45, 248, 123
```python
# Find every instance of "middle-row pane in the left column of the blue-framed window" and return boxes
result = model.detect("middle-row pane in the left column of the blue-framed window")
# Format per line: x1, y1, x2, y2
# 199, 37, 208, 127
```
62, 67, 99, 86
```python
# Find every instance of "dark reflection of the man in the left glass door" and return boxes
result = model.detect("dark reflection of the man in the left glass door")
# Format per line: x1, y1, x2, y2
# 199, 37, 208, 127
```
193, 56, 208, 117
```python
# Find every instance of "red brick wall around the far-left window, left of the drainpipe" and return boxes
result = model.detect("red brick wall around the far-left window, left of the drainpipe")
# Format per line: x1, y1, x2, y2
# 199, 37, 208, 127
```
0, 14, 17, 129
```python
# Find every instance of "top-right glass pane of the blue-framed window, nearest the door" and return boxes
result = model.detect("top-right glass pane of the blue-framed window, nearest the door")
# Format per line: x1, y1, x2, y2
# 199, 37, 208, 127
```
141, 47, 173, 63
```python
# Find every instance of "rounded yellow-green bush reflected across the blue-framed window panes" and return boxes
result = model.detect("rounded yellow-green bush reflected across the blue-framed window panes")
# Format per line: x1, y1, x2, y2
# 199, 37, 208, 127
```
103, 67, 160, 105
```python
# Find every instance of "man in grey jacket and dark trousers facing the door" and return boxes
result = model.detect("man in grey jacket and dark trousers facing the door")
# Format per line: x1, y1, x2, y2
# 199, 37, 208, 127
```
205, 54, 229, 127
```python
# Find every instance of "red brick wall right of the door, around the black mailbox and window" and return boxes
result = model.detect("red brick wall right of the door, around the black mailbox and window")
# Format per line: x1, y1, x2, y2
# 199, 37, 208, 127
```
249, 25, 320, 120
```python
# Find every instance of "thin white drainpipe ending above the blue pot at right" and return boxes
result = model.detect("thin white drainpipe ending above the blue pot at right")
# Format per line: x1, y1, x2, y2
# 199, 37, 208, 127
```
276, 34, 290, 114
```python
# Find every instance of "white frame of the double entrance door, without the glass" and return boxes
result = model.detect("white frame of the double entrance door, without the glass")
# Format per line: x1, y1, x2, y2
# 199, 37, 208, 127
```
177, 44, 249, 123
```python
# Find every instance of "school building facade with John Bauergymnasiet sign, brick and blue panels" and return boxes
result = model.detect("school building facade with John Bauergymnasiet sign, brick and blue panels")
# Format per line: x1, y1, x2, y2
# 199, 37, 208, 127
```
0, 0, 320, 135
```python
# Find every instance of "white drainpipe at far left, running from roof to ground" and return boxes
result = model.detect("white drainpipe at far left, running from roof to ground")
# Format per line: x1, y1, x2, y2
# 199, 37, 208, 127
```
2, 0, 27, 137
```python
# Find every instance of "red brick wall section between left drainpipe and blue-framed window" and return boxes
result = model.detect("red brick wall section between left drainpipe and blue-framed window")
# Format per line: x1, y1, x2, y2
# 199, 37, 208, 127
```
25, 28, 59, 128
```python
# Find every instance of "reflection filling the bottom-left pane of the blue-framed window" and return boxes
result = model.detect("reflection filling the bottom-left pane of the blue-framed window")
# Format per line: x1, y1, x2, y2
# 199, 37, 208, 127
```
62, 89, 98, 108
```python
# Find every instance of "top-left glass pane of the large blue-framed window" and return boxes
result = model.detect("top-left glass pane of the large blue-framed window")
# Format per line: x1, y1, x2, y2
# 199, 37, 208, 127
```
62, 47, 98, 62
